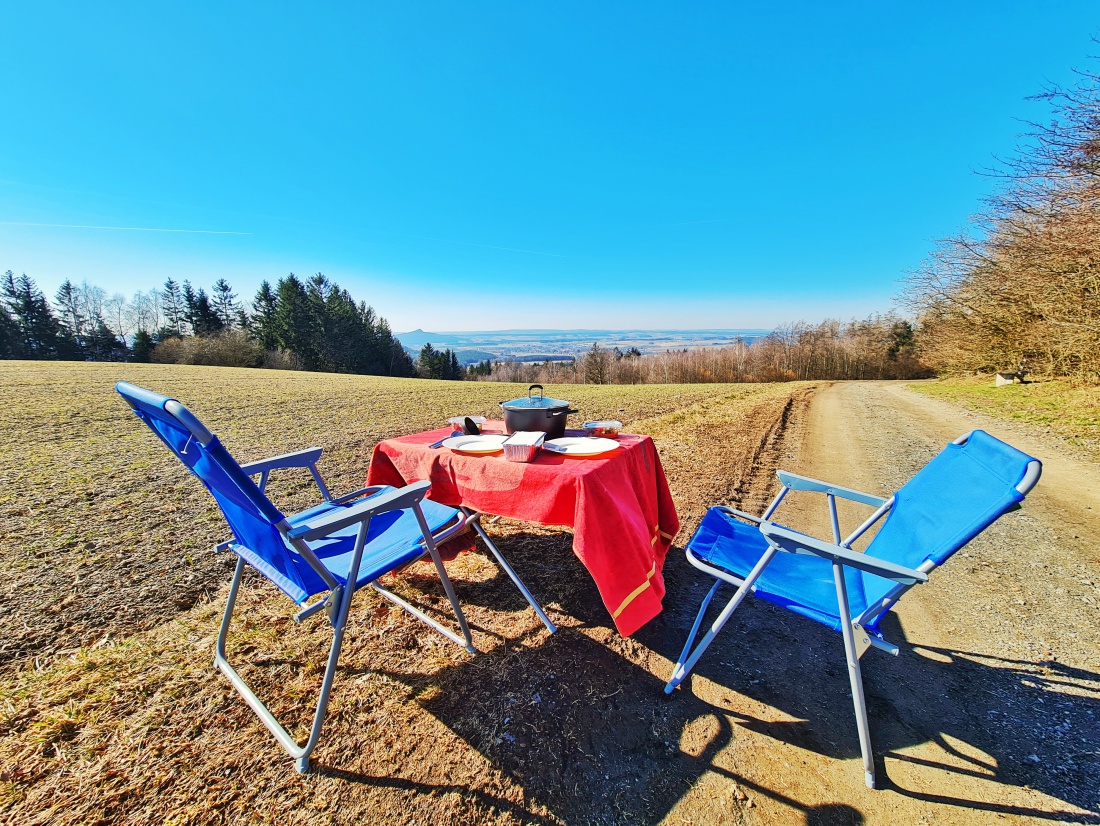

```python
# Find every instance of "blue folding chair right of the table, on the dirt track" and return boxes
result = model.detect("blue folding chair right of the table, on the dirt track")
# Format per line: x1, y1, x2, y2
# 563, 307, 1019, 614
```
664, 430, 1043, 789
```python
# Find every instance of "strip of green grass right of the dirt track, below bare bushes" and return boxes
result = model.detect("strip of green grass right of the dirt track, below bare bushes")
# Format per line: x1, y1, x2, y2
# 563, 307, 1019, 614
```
910, 376, 1100, 460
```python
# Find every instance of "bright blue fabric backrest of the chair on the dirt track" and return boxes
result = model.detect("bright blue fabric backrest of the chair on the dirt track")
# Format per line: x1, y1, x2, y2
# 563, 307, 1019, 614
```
865, 430, 1042, 604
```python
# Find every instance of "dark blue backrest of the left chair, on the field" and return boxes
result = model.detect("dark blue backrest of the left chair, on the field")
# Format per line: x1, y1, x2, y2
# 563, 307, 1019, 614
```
114, 382, 303, 592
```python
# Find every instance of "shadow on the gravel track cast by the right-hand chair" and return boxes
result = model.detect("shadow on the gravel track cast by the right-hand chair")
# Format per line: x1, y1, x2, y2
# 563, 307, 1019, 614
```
638, 549, 1100, 824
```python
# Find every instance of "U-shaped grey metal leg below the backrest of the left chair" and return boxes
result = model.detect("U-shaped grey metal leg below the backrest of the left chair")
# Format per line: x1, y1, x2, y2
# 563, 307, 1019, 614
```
215, 558, 354, 773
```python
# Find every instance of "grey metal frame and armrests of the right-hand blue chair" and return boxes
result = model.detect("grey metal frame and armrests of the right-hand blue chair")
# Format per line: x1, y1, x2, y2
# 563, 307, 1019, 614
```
664, 433, 1042, 789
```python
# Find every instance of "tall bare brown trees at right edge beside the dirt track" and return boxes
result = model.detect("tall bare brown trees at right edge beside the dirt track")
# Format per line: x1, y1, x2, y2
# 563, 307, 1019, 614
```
904, 58, 1100, 382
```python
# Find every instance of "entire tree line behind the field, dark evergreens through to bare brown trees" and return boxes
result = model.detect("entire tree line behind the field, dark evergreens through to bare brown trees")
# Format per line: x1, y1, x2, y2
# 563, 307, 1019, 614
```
0, 271, 933, 384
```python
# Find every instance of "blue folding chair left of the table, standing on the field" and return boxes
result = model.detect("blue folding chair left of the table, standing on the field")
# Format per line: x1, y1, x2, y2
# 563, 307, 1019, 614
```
116, 382, 486, 772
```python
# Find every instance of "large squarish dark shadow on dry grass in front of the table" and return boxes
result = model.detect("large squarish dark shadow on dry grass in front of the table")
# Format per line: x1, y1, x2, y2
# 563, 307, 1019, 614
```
326, 627, 733, 824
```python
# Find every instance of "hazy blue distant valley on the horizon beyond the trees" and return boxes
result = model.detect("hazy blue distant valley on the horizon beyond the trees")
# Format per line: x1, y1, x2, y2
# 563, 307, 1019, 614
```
395, 329, 771, 364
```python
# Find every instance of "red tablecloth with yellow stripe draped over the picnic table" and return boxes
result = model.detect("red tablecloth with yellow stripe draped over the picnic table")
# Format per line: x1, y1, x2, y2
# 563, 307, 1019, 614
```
366, 421, 680, 637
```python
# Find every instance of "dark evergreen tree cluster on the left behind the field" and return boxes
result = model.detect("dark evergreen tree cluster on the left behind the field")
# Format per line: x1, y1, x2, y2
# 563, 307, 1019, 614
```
0, 271, 418, 376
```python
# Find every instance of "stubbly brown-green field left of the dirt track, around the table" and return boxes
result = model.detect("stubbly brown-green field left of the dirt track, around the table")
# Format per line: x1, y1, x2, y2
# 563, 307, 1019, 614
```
0, 362, 813, 824
